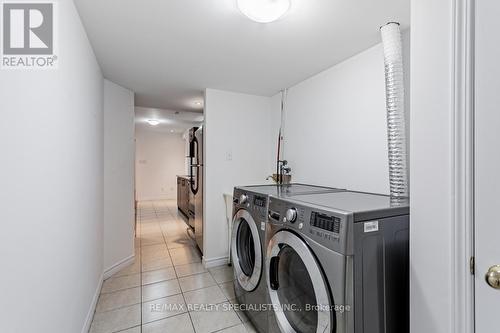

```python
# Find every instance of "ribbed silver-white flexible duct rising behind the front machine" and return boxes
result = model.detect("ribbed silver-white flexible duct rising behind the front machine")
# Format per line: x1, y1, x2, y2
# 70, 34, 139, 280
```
380, 22, 408, 197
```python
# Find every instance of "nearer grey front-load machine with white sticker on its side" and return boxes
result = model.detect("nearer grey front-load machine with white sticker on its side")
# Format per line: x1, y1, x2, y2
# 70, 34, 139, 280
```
264, 191, 409, 333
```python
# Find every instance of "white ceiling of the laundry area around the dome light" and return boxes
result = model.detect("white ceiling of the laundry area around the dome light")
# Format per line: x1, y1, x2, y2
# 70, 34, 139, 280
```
75, 0, 410, 111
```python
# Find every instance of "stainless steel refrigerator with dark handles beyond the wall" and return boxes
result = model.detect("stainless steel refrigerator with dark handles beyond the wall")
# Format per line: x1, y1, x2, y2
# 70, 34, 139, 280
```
188, 127, 203, 252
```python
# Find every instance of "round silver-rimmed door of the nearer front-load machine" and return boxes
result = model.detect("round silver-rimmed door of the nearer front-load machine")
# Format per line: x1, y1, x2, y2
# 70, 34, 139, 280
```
266, 231, 335, 333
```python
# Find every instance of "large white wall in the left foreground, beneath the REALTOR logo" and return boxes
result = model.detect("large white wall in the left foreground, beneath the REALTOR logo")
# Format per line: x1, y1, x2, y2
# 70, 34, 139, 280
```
0, 1, 103, 333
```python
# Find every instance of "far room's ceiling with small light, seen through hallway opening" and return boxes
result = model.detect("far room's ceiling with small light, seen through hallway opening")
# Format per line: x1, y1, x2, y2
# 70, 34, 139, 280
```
135, 107, 203, 133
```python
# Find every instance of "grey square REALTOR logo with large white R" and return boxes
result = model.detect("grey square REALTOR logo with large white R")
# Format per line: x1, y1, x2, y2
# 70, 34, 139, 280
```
1, 1, 57, 69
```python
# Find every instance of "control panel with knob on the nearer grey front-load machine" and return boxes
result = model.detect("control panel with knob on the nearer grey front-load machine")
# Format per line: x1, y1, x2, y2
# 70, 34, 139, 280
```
268, 198, 349, 253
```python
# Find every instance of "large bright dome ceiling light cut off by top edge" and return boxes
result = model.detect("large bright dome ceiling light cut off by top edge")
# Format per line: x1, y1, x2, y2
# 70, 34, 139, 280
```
237, 0, 290, 23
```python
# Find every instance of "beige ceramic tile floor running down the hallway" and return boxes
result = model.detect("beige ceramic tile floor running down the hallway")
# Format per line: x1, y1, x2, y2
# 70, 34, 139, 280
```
90, 200, 255, 333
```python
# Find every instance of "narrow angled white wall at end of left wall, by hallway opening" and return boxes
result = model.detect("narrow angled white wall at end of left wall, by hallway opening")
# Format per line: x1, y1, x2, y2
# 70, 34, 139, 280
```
104, 80, 135, 275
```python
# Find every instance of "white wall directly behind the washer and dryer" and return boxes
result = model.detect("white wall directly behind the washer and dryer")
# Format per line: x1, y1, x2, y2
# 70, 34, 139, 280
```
271, 32, 409, 193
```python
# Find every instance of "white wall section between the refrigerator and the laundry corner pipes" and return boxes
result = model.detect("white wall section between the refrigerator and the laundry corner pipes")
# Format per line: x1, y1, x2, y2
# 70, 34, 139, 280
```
203, 89, 272, 265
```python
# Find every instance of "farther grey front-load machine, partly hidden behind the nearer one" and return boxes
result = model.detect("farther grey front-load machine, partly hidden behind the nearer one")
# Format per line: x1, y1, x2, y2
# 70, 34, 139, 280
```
231, 184, 346, 333
